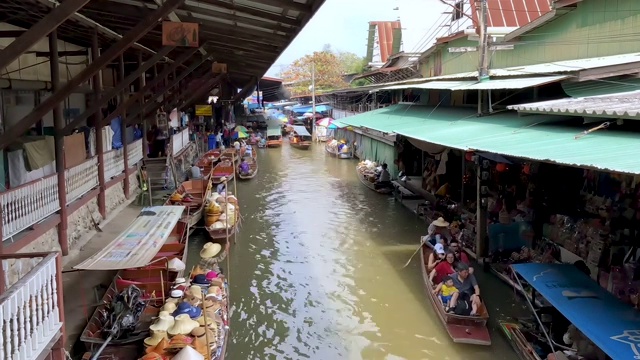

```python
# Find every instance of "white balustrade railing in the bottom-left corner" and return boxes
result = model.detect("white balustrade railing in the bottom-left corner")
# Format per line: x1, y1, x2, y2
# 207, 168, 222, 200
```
0, 253, 64, 360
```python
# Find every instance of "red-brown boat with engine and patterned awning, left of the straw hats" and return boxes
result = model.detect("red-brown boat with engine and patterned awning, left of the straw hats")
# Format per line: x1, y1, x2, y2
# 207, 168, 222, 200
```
75, 206, 188, 360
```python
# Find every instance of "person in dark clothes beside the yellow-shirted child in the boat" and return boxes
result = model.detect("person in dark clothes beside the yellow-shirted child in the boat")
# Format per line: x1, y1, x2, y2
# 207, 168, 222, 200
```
444, 263, 482, 316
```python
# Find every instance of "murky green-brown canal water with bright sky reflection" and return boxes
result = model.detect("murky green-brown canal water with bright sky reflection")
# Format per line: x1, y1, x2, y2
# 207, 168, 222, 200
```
190, 141, 522, 360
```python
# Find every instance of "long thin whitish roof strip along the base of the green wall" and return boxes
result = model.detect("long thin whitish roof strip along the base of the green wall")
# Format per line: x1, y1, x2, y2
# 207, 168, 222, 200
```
422, 53, 640, 80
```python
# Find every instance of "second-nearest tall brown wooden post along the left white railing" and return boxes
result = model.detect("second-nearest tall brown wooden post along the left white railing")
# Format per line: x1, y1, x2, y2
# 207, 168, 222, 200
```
91, 30, 107, 219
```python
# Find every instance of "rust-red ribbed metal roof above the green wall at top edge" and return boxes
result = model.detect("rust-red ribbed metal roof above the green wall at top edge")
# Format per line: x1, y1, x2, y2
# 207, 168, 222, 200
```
470, 0, 551, 27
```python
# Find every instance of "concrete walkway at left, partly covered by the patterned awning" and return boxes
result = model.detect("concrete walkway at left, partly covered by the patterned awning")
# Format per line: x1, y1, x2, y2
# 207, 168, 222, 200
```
62, 199, 142, 351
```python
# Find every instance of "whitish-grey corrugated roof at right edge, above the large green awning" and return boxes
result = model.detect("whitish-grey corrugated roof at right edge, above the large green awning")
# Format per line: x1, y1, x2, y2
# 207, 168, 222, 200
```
508, 91, 640, 120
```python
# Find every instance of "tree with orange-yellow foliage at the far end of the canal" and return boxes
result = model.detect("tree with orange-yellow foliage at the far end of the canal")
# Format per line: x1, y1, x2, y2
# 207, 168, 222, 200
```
282, 51, 347, 95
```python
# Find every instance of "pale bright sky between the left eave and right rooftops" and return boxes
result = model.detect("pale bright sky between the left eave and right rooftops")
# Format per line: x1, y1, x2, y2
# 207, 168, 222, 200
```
267, 0, 447, 76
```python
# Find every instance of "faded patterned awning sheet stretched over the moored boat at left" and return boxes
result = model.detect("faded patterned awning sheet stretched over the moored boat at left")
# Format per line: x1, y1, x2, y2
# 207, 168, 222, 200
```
74, 206, 184, 270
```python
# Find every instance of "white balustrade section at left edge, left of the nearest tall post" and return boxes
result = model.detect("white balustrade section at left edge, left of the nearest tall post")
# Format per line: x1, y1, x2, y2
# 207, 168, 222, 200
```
0, 174, 60, 240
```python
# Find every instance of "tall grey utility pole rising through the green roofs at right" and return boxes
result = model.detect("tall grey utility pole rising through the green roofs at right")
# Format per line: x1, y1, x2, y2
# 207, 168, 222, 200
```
475, 0, 490, 263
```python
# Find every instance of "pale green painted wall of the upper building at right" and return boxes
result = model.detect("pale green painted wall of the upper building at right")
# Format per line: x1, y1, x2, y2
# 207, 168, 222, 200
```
421, 0, 640, 75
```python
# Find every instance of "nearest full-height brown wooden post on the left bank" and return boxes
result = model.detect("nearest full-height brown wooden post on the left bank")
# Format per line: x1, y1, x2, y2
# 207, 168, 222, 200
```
49, 29, 69, 256
